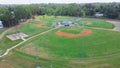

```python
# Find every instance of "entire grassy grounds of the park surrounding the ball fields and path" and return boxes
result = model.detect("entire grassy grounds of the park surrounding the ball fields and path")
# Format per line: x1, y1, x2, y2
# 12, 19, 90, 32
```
0, 16, 120, 68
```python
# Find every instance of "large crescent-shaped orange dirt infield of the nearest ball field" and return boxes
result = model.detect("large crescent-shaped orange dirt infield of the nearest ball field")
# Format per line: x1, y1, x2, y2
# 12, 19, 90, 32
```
56, 29, 92, 37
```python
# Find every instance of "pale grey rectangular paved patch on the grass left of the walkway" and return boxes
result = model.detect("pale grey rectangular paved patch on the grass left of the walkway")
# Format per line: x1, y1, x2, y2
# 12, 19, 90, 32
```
7, 32, 28, 41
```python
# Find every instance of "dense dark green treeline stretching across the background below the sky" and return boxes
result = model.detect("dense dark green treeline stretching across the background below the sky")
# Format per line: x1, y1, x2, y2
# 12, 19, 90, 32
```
0, 3, 120, 27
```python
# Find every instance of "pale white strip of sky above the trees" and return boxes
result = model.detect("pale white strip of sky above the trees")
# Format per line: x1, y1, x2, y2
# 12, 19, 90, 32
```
0, 0, 120, 4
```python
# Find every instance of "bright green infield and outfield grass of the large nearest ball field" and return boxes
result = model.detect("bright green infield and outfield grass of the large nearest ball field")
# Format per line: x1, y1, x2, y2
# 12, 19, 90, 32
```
17, 27, 120, 59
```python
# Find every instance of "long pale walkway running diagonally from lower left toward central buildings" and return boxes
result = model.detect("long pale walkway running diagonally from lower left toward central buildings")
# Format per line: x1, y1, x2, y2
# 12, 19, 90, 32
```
0, 28, 58, 58
